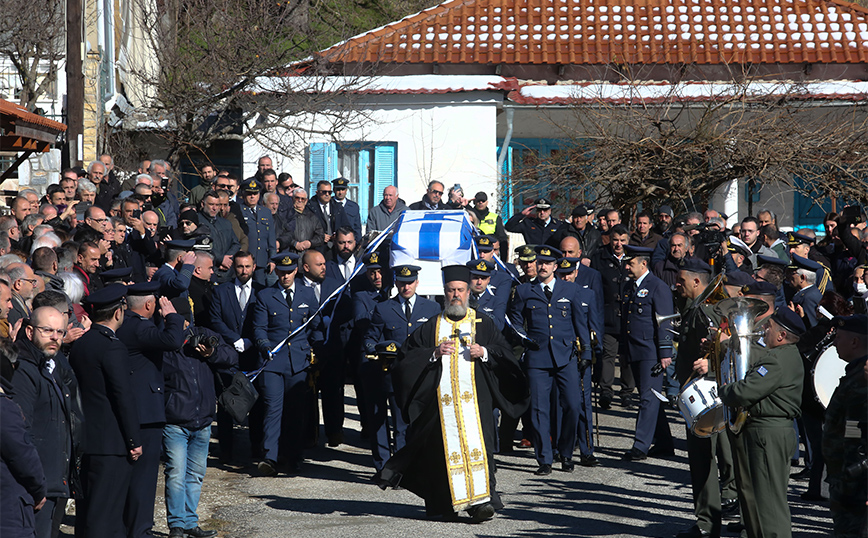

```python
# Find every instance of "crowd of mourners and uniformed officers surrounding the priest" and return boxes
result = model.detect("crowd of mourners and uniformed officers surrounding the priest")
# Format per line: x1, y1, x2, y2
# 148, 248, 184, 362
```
0, 151, 868, 538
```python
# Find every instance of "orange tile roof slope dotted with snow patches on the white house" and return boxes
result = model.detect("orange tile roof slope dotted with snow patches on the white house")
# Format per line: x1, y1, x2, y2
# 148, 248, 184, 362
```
322, 0, 868, 65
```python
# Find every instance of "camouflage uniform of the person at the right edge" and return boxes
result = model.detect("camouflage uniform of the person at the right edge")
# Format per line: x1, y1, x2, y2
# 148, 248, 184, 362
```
823, 357, 868, 538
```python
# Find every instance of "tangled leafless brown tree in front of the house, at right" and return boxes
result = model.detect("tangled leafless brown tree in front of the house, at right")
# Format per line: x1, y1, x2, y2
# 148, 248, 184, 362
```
513, 74, 868, 219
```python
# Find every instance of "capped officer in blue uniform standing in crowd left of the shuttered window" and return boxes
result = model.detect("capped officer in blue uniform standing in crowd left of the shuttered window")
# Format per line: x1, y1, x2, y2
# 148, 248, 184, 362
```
240, 178, 277, 286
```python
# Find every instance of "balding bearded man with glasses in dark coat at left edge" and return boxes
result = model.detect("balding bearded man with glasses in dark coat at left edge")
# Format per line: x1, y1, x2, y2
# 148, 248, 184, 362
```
12, 306, 79, 538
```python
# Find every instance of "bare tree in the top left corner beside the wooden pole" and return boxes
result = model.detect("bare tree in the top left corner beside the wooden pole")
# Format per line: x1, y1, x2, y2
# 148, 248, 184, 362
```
0, 0, 65, 111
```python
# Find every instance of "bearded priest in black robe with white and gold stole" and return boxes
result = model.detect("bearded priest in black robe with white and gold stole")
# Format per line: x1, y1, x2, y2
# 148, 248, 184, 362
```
378, 265, 528, 522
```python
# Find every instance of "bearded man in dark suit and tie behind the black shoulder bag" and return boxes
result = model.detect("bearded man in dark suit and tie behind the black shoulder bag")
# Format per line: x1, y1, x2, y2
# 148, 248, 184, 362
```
211, 250, 263, 461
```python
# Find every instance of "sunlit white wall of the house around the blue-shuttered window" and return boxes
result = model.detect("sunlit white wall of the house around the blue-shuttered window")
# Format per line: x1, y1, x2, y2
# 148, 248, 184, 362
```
244, 92, 500, 204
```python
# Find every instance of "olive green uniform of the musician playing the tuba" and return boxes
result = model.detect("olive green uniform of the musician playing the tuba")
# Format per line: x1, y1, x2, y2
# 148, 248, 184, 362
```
720, 343, 804, 537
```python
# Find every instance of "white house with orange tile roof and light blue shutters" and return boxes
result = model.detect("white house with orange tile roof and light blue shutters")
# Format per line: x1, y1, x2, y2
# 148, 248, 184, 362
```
245, 0, 868, 227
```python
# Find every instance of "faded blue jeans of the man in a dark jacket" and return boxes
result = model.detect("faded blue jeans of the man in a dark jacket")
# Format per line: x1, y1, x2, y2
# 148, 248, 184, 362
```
163, 424, 211, 529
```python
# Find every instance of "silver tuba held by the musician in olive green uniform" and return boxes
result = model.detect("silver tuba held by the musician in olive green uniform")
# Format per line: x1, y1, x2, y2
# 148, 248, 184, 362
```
713, 297, 769, 434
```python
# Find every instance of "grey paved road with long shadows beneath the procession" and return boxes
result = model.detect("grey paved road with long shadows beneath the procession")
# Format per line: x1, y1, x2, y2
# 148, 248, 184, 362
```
178, 395, 831, 538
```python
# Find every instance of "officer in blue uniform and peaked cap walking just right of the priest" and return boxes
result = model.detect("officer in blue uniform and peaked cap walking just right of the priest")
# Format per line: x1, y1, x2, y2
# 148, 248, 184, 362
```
509, 245, 590, 476
